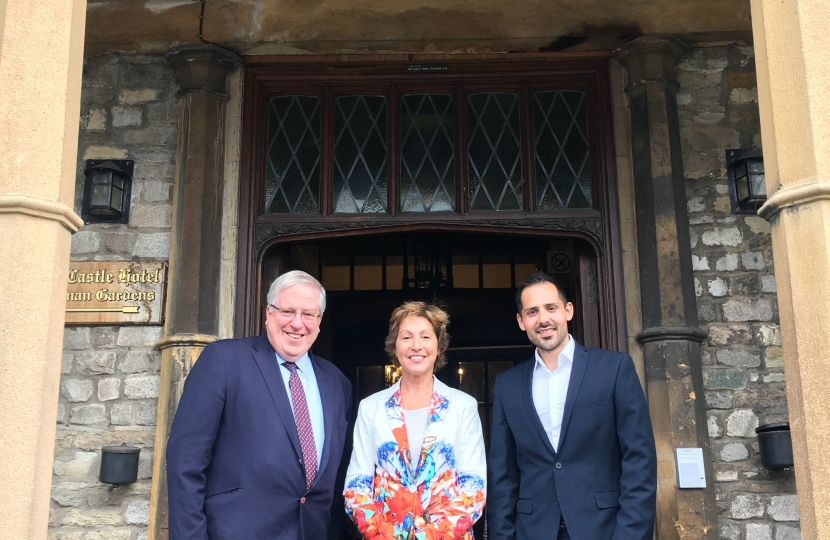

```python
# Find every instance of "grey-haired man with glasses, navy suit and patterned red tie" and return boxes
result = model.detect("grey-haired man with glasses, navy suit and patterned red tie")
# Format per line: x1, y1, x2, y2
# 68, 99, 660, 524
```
167, 271, 352, 540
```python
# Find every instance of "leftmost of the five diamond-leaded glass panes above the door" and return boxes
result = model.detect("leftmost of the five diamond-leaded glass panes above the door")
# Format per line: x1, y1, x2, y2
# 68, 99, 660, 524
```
265, 96, 321, 214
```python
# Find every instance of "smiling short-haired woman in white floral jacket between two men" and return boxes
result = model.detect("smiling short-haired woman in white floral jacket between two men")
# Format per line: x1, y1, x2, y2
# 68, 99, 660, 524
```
344, 302, 487, 540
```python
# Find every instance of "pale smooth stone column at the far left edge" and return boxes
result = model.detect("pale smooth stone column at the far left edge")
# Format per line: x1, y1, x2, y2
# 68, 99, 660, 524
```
0, 0, 86, 540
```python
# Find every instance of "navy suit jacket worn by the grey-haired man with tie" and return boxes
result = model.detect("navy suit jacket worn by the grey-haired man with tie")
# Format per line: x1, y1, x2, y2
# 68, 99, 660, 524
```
167, 336, 352, 540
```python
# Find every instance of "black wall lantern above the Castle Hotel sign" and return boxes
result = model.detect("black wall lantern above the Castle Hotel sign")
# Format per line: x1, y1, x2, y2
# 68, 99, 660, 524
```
81, 159, 135, 223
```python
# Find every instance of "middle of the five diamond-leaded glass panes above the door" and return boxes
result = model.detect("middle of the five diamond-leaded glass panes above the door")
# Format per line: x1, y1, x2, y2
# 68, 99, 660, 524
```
401, 94, 455, 212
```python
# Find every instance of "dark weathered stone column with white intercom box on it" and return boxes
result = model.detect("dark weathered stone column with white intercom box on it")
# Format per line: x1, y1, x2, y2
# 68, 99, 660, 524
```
617, 37, 717, 540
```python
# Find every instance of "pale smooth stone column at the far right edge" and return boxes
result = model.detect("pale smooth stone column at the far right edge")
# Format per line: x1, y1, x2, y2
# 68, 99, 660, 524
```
752, 0, 830, 540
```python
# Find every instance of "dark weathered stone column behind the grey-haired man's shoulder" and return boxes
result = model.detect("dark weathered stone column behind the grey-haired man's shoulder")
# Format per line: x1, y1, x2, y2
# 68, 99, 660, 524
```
149, 45, 239, 540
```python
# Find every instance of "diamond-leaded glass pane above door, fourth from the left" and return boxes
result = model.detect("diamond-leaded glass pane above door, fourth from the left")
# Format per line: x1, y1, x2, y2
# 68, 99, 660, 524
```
467, 92, 523, 210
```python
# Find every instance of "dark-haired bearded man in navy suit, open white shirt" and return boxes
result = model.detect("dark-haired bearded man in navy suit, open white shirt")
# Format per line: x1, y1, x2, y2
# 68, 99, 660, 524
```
487, 274, 657, 540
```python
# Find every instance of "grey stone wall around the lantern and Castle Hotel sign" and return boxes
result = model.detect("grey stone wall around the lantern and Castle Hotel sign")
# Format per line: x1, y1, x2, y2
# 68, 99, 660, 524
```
50, 55, 178, 540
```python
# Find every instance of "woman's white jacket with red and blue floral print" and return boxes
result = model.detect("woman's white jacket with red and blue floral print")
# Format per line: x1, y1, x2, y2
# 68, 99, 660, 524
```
344, 379, 487, 540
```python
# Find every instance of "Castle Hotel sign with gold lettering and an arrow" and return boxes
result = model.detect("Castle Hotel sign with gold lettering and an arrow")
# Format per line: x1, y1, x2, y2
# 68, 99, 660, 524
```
66, 261, 167, 324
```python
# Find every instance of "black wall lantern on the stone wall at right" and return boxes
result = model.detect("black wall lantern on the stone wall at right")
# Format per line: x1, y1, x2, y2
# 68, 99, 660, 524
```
726, 148, 767, 214
